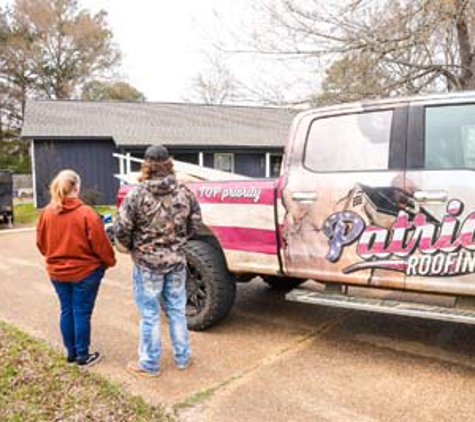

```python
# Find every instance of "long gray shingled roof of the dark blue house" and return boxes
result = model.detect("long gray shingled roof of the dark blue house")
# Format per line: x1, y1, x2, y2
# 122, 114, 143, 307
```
22, 101, 297, 147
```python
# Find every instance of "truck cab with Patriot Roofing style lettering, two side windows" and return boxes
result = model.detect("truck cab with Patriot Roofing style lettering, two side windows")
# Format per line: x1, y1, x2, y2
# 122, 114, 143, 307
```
281, 95, 475, 295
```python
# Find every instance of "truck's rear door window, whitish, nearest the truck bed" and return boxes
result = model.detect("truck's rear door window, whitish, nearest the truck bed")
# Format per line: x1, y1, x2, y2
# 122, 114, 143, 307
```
304, 110, 393, 172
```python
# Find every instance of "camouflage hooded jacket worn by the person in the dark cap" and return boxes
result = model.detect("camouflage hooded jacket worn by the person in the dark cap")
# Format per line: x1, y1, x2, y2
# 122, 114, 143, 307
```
114, 175, 205, 274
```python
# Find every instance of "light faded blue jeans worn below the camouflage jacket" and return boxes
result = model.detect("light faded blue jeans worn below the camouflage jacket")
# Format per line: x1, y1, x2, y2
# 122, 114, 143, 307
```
134, 266, 191, 373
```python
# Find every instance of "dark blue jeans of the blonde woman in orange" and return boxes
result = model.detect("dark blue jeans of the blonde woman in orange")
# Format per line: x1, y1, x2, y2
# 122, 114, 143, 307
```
52, 267, 104, 360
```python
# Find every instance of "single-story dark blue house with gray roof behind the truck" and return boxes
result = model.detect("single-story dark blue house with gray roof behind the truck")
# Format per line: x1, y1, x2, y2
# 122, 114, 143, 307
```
22, 101, 296, 207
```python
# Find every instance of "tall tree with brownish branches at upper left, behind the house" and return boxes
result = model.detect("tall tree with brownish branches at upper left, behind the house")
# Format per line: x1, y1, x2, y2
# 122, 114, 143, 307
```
0, 0, 120, 131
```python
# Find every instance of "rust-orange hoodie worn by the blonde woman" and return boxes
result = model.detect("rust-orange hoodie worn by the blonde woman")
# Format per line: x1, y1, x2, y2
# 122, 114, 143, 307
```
36, 198, 116, 282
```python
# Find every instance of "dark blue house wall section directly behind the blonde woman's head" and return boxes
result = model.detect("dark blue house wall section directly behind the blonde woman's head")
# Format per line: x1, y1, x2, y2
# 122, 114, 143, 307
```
34, 139, 119, 207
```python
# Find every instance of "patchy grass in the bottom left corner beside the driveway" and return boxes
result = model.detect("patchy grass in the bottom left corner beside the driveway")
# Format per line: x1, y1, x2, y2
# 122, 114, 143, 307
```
0, 322, 172, 422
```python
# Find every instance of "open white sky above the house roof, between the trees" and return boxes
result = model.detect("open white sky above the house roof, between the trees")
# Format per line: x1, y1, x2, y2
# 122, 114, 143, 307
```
0, 0, 313, 103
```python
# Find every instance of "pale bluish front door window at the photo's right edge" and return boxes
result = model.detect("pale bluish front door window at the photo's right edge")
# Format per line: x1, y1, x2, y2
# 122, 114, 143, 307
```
424, 104, 475, 170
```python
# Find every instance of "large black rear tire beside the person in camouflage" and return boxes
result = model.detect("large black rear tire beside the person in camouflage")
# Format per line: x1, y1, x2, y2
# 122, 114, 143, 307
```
185, 240, 236, 331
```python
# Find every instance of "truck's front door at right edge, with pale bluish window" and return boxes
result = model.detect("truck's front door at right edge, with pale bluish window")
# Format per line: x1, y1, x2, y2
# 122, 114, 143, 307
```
406, 99, 475, 295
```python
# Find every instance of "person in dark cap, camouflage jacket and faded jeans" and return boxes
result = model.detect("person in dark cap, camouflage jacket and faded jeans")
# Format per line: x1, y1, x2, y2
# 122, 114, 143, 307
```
114, 146, 201, 377
